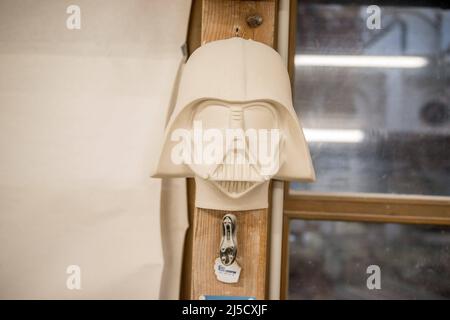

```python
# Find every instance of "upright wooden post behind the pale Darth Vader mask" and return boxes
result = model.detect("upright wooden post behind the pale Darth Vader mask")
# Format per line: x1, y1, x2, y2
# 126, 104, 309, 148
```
181, 0, 277, 299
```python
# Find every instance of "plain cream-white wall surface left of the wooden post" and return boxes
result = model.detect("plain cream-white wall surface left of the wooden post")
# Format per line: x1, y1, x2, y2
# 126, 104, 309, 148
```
0, 0, 190, 299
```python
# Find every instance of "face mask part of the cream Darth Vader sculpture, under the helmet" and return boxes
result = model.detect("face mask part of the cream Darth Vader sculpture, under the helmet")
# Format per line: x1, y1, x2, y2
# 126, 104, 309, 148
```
188, 101, 282, 198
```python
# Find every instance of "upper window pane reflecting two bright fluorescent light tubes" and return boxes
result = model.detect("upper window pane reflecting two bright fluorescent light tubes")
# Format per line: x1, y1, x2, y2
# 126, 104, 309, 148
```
291, 1, 450, 195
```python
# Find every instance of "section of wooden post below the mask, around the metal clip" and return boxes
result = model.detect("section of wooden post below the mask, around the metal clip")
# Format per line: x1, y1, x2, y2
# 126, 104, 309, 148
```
191, 208, 268, 299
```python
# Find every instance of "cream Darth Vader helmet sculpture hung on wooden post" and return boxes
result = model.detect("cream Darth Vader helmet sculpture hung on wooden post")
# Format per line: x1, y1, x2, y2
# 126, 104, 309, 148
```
153, 38, 315, 211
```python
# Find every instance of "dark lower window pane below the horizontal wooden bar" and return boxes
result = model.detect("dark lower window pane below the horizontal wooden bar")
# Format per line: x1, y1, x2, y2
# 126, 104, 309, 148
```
288, 220, 450, 299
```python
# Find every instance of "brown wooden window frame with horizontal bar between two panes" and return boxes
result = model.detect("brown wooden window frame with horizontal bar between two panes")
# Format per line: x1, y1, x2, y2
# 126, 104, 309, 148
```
280, 0, 450, 299
